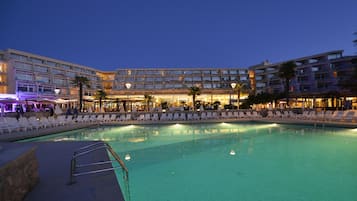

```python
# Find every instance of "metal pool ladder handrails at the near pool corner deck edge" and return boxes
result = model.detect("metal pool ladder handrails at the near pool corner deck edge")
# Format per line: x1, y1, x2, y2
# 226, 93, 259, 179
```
68, 142, 130, 200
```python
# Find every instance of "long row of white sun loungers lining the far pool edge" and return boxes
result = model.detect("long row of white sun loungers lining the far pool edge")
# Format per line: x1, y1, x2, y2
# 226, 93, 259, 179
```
0, 110, 357, 134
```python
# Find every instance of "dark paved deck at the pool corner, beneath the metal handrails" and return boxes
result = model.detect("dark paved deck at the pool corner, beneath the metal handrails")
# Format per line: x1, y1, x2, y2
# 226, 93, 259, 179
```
0, 142, 124, 201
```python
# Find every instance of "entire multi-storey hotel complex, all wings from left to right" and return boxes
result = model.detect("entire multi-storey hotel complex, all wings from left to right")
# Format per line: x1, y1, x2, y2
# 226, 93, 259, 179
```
0, 49, 356, 111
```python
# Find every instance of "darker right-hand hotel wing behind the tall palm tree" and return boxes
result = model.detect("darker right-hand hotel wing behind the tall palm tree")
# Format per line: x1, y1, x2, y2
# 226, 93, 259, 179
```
249, 50, 357, 107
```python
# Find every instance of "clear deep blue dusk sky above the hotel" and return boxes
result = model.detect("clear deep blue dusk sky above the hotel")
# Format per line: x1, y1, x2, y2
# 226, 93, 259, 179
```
0, 0, 357, 70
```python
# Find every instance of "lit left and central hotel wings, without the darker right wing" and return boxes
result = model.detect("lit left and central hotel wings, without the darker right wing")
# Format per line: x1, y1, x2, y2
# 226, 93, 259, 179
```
0, 49, 250, 111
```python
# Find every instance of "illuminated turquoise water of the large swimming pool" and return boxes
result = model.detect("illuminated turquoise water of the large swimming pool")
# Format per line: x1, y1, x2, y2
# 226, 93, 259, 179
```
23, 123, 357, 201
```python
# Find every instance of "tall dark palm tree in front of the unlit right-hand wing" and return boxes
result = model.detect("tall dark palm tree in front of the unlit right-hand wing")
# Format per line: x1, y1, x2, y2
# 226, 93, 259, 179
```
279, 61, 296, 106
